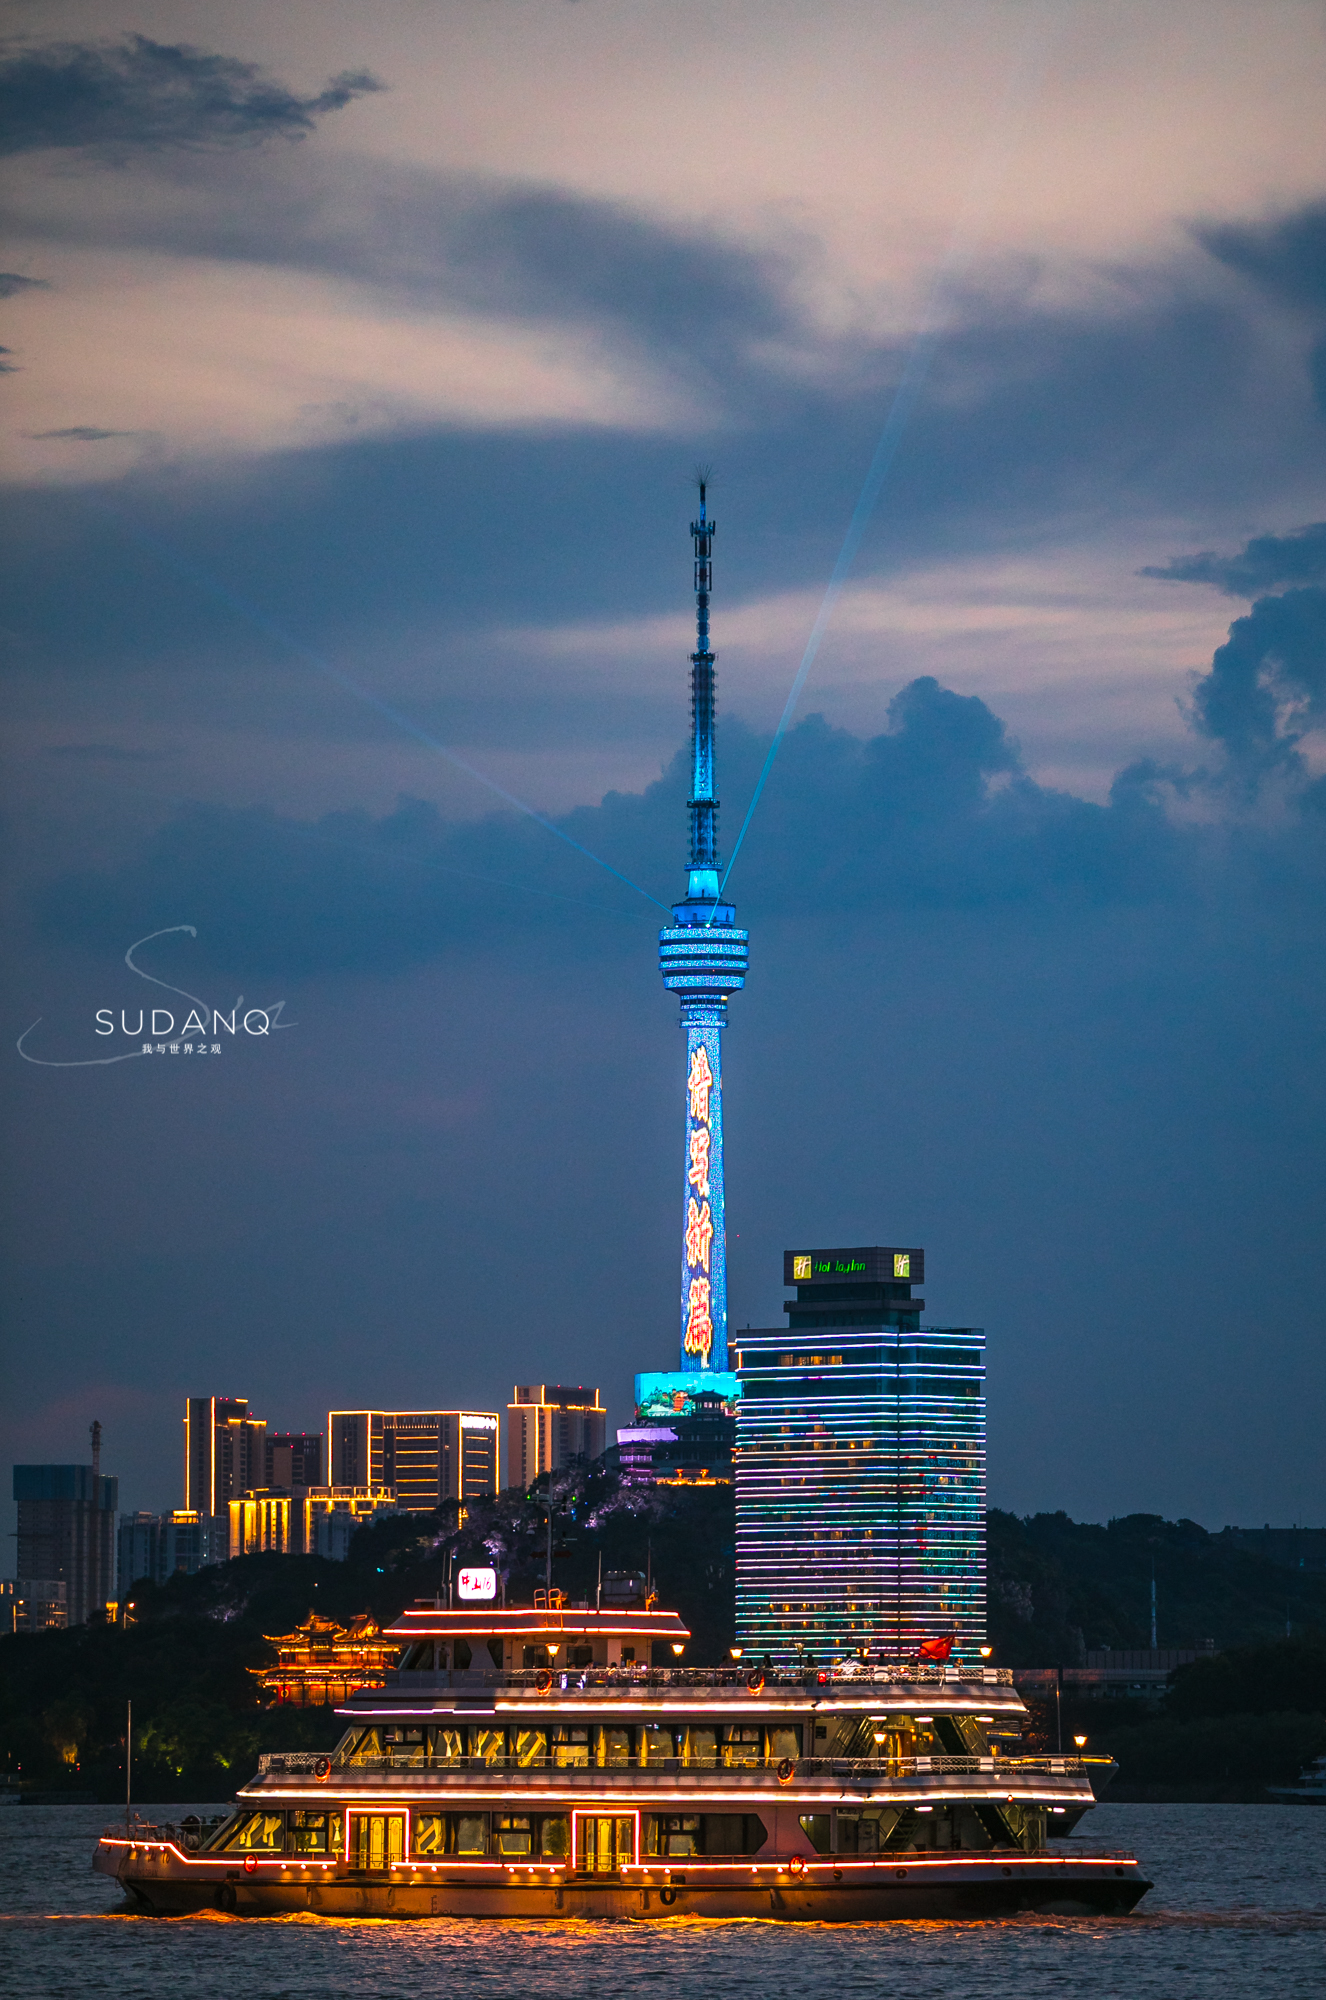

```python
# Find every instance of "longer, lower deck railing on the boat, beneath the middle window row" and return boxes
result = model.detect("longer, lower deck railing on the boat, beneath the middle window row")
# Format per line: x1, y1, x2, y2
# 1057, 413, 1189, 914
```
258, 1744, 1086, 1786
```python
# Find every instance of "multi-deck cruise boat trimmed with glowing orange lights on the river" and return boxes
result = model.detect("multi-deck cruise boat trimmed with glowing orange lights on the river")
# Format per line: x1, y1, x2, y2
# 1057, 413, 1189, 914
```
94, 1592, 1150, 1922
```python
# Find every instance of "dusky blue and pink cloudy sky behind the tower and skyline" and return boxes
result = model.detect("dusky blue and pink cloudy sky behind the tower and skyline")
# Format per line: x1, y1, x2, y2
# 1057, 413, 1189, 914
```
0, 0, 1326, 1528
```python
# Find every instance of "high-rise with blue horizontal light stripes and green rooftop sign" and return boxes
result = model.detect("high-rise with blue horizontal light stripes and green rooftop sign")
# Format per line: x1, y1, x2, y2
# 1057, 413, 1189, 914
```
732, 1246, 986, 1666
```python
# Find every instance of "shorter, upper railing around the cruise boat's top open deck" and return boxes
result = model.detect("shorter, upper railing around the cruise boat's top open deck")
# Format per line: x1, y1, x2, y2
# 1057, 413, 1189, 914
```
386, 1664, 1012, 1694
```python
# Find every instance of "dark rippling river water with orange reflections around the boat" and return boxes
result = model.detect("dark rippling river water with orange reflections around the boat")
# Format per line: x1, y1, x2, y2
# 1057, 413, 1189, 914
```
0, 1804, 1326, 2000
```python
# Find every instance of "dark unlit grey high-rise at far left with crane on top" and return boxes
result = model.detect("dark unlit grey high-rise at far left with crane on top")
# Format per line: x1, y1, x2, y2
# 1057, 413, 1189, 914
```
14, 1464, 120, 1624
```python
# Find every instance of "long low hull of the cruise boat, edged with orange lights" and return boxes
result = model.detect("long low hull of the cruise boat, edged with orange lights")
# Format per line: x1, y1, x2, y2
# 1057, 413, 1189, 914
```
94, 1842, 1150, 1924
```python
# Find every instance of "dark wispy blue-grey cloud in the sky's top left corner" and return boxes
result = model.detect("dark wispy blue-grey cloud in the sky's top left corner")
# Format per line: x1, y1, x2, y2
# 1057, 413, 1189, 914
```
0, 34, 384, 160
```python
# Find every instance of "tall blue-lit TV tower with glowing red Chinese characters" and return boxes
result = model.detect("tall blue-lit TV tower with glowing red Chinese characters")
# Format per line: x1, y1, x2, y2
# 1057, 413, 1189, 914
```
658, 480, 750, 1374
